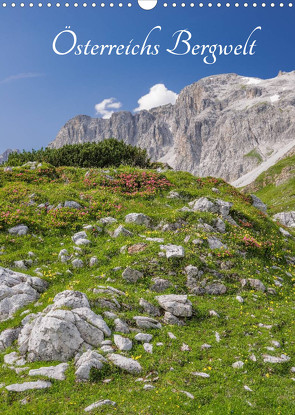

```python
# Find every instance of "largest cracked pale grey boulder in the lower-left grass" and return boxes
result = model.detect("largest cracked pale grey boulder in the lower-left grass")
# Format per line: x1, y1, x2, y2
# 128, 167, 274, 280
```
18, 291, 111, 362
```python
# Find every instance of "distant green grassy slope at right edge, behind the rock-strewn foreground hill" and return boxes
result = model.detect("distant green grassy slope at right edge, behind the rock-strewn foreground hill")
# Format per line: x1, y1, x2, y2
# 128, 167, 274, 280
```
244, 154, 295, 214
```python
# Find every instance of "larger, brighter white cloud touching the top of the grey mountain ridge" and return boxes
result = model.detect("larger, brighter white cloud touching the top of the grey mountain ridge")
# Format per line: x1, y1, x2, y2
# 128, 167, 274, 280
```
134, 84, 177, 111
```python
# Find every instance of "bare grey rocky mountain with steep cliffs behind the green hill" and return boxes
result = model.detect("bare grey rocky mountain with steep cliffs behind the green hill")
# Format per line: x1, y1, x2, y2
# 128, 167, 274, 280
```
50, 71, 295, 182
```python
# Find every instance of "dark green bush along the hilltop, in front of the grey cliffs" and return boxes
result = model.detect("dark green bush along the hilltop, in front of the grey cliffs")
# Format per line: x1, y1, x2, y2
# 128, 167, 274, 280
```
6, 138, 150, 168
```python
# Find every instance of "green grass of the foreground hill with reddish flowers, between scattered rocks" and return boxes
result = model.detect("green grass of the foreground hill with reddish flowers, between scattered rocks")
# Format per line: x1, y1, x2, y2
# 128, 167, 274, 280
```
0, 166, 295, 415
